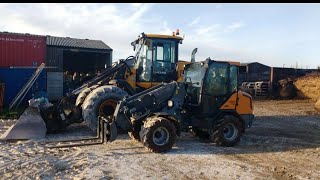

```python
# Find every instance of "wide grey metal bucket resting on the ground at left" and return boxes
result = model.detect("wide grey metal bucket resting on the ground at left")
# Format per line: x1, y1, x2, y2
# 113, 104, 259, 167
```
0, 106, 47, 140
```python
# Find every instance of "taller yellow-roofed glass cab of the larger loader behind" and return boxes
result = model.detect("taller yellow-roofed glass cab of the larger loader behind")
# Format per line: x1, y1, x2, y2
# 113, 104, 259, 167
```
132, 34, 183, 89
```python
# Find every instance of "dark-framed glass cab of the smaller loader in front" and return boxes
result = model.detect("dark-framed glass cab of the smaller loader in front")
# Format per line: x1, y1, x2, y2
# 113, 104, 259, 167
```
185, 59, 237, 114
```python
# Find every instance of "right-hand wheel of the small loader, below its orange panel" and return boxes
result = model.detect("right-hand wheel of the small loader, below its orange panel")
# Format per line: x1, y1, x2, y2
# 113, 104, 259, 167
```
209, 116, 242, 147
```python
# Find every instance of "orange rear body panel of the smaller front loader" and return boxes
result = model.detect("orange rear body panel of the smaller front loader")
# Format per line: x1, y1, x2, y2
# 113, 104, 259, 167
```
220, 91, 253, 115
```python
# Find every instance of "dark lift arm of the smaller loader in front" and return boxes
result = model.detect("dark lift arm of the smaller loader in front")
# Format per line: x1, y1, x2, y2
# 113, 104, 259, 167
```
106, 81, 186, 141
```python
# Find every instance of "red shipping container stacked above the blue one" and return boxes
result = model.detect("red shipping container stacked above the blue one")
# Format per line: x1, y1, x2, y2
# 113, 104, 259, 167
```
0, 32, 46, 67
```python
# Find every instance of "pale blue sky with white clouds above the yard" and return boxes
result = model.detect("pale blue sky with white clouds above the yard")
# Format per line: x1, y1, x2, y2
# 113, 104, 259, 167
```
0, 3, 320, 68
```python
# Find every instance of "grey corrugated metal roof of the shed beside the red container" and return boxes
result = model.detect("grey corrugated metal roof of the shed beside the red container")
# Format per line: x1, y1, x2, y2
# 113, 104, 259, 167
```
47, 36, 112, 50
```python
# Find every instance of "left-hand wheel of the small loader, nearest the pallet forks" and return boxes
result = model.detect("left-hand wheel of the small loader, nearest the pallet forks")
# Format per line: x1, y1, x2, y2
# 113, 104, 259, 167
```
140, 117, 177, 153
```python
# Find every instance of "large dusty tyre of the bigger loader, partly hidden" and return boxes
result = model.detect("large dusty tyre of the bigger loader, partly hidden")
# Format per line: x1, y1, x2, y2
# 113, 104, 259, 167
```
82, 85, 128, 132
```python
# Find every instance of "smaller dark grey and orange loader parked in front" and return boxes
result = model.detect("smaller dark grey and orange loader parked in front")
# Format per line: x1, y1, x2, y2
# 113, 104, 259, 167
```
105, 59, 254, 153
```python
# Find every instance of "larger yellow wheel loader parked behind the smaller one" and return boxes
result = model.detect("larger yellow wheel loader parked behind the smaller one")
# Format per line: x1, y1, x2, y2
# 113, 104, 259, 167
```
3, 30, 194, 139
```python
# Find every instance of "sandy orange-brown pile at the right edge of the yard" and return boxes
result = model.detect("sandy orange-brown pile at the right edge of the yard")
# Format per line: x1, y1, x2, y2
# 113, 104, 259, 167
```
294, 75, 320, 102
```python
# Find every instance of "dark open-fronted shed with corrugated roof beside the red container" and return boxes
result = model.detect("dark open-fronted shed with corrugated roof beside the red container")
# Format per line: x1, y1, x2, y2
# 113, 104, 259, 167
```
46, 36, 112, 101
